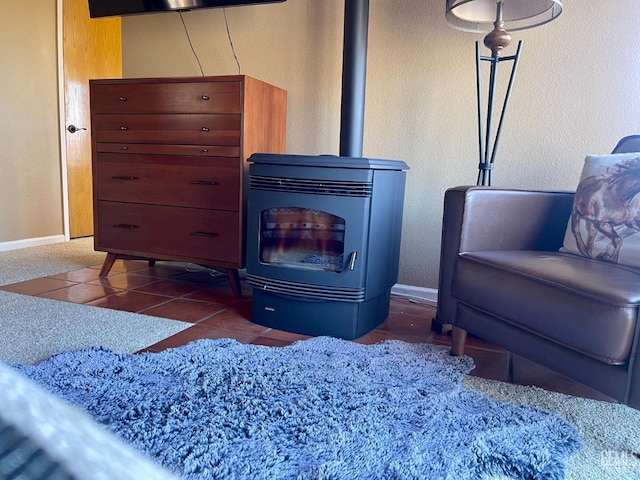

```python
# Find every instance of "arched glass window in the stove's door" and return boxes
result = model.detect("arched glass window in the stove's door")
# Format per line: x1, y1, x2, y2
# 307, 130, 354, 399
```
259, 207, 345, 273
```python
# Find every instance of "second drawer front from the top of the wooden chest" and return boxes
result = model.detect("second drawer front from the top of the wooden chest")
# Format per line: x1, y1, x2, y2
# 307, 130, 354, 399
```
91, 114, 240, 146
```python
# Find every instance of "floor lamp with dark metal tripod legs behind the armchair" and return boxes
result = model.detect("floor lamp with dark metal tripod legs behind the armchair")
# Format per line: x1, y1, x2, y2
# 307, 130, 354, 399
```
446, 0, 562, 185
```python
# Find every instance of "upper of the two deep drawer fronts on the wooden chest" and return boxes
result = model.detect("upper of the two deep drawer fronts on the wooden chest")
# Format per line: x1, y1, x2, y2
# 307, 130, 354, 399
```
96, 154, 241, 212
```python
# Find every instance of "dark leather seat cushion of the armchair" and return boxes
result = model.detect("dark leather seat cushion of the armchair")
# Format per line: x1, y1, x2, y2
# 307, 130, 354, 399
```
451, 250, 640, 365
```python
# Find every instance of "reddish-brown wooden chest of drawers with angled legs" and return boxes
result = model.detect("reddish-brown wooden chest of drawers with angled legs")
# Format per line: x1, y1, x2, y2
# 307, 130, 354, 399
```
90, 75, 286, 296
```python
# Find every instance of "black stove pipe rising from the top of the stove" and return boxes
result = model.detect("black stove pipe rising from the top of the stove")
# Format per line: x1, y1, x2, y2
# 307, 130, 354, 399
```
340, 0, 369, 157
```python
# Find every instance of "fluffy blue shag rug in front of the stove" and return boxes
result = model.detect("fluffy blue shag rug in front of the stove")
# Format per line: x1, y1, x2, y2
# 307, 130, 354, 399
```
14, 337, 581, 480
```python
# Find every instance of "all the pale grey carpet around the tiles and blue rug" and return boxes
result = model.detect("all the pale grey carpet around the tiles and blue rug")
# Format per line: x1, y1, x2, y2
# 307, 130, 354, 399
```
0, 239, 640, 480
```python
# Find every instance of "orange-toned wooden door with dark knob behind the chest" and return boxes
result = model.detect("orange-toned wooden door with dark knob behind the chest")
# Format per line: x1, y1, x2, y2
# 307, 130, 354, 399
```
62, 0, 122, 238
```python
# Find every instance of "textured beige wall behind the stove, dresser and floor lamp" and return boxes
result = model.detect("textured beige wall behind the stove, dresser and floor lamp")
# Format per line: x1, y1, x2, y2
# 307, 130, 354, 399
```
122, 0, 640, 288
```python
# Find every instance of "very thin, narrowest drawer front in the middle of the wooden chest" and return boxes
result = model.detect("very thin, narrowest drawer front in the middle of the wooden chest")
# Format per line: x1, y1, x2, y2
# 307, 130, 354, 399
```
95, 143, 240, 159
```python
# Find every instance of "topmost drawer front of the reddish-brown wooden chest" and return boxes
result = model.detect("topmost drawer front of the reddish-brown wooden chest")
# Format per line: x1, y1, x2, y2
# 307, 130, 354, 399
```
91, 82, 242, 114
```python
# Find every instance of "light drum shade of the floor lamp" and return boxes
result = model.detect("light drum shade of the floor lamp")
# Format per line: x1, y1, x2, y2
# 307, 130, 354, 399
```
446, 0, 562, 33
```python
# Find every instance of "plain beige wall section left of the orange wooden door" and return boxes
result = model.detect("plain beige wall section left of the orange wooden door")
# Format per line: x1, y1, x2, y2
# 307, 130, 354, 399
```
0, 0, 63, 248
